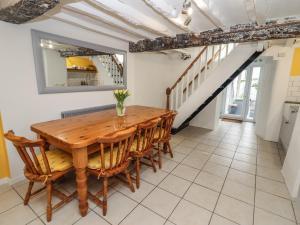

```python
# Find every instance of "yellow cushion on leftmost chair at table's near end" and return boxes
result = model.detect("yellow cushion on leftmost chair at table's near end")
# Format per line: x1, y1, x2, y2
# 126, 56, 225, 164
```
37, 149, 73, 174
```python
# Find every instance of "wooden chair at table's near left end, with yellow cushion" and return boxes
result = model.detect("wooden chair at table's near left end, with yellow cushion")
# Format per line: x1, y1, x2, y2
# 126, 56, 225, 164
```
4, 131, 76, 222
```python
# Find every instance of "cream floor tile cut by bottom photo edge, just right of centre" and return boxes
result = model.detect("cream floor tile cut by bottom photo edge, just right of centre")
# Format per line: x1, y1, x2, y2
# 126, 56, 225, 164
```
169, 200, 212, 225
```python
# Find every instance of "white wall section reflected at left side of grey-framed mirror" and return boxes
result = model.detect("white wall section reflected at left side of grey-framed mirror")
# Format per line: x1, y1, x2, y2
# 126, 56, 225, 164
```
43, 48, 67, 87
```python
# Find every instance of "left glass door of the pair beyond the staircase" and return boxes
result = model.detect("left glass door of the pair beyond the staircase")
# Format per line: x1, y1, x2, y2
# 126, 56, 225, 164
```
223, 70, 247, 119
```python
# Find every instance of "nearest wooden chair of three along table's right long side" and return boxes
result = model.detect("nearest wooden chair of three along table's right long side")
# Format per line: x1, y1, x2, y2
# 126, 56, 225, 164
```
88, 127, 136, 216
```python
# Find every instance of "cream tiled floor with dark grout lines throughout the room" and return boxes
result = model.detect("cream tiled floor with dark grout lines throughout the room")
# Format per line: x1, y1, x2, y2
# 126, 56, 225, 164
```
0, 122, 300, 225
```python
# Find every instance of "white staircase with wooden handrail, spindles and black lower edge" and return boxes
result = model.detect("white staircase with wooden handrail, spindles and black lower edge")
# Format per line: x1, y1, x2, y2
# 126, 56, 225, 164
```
166, 43, 262, 133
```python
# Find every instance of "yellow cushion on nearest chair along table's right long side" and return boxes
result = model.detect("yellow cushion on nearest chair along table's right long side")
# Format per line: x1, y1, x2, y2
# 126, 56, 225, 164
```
88, 148, 122, 169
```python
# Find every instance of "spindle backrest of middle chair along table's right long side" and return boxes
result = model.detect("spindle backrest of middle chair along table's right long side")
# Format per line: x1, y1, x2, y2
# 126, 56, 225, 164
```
134, 118, 161, 153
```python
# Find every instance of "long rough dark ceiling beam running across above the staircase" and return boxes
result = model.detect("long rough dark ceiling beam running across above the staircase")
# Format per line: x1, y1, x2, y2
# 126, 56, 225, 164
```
129, 20, 300, 52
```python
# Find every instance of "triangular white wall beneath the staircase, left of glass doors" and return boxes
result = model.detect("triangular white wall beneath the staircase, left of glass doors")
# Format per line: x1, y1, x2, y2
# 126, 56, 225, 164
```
190, 94, 222, 130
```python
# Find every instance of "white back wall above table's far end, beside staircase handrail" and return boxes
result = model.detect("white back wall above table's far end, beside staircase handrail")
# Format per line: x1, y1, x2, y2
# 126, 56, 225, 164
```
135, 48, 201, 107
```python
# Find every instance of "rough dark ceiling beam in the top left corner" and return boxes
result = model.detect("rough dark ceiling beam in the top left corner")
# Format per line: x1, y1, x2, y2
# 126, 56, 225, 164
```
0, 0, 60, 24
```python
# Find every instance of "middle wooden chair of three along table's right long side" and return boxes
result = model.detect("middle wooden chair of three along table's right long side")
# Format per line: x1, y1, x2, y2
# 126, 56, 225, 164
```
130, 119, 160, 188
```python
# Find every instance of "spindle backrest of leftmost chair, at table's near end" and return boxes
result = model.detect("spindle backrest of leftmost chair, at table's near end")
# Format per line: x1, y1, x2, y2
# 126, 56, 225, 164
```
4, 130, 51, 176
